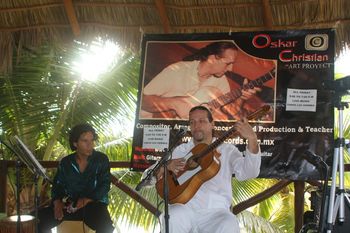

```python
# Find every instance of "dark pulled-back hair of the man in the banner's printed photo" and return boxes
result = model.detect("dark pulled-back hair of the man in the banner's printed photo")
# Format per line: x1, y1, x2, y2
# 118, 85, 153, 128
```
182, 41, 238, 61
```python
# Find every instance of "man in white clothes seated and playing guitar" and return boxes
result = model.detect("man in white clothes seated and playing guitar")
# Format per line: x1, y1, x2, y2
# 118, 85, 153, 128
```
157, 106, 261, 233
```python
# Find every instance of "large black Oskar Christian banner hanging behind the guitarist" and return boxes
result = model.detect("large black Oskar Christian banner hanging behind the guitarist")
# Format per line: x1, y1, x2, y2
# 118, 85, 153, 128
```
131, 29, 334, 180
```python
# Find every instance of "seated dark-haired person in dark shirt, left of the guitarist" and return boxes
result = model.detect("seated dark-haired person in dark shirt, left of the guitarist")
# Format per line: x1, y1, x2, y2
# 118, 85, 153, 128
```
38, 124, 114, 233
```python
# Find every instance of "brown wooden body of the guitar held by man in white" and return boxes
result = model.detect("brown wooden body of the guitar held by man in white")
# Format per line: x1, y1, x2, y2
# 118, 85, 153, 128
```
156, 143, 220, 204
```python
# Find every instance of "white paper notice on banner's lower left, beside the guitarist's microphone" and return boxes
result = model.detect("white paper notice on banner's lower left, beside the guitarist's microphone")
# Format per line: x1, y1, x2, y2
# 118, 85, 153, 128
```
142, 127, 170, 150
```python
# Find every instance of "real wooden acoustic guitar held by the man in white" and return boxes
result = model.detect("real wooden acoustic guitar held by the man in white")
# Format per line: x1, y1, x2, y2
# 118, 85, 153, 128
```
156, 105, 270, 204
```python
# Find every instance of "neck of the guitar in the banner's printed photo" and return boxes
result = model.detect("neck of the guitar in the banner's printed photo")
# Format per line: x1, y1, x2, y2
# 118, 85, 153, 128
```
207, 69, 275, 109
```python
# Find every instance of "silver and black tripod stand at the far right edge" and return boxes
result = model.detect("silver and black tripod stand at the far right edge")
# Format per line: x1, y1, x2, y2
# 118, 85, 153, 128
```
326, 76, 350, 233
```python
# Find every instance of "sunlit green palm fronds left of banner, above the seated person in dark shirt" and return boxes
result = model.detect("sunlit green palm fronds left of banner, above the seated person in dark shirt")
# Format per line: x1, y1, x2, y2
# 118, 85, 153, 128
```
0, 43, 139, 159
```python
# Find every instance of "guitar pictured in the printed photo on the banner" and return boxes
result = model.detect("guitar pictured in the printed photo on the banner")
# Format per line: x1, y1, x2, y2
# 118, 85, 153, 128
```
152, 68, 275, 120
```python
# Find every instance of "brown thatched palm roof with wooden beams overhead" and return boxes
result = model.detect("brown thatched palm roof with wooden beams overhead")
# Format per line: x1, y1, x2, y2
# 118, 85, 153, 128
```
0, 0, 350, 73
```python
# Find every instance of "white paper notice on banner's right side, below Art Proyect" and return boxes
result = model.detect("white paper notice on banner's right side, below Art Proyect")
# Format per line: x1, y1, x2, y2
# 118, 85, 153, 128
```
286, 88, 317, 112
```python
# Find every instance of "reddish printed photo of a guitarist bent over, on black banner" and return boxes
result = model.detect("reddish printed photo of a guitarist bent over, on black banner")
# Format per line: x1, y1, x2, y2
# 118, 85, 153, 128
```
139, 40, 277, 122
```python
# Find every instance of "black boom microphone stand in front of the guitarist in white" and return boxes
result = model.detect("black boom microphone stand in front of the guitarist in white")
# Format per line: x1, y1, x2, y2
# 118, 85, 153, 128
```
135, 131, 186, 233
